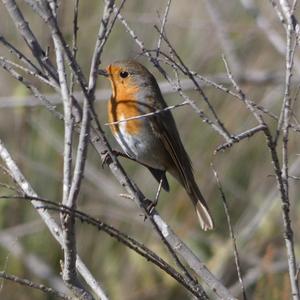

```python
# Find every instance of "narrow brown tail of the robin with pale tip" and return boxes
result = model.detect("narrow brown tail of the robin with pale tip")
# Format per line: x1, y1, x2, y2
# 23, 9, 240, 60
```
187, 182, 214, 231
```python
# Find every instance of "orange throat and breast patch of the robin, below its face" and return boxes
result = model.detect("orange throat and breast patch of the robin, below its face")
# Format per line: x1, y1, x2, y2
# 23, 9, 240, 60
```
108, 81, 143, 134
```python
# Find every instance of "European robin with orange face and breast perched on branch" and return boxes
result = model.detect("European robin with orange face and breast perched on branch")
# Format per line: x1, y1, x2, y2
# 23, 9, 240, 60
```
99, 60, 214, 230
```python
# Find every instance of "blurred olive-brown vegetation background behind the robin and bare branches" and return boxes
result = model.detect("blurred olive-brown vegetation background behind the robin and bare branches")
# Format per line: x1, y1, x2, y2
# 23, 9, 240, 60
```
0, 0, 300, 300
